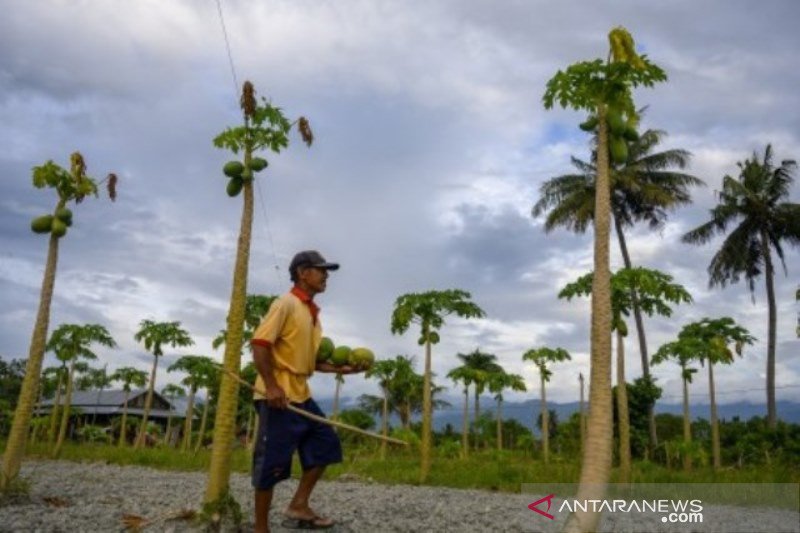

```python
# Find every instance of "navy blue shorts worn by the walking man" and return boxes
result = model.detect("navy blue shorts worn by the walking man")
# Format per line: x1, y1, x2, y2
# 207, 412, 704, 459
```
253, 398, 342, 490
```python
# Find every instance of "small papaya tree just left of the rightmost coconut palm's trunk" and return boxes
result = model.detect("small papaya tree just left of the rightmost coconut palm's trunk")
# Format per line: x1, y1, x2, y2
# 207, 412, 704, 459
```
678, 317, 755, 469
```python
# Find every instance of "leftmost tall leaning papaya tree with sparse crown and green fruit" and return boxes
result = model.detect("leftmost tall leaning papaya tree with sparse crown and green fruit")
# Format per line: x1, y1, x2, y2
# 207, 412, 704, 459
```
0, 152, 117, 491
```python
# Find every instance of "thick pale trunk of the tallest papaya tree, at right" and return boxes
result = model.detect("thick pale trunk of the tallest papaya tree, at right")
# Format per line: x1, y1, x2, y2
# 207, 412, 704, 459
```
565, 108, 613, 533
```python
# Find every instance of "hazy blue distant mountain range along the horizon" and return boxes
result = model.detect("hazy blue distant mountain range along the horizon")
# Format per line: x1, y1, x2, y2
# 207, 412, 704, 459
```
317, 396, 800, 429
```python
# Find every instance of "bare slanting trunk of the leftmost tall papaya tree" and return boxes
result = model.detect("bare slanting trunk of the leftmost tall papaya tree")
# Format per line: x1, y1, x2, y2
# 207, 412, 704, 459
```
0, 221, 65, 490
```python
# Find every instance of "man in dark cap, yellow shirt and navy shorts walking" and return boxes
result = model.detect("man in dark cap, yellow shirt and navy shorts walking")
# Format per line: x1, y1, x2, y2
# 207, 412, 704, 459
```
251, 250, 358, 533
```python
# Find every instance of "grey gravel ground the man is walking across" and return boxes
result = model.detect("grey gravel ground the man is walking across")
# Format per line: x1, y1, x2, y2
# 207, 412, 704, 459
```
0, 461, 800, 533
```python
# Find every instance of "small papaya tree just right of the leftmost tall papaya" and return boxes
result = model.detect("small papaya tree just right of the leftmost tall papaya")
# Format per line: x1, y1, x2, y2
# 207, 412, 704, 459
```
47, 324, 117, 459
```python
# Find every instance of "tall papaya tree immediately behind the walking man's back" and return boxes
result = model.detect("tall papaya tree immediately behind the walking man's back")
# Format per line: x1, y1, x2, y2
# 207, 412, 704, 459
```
203, 81, 314, 514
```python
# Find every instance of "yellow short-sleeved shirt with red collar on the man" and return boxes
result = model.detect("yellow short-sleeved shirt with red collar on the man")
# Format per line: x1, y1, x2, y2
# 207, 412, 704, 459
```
251, 287, 322, 402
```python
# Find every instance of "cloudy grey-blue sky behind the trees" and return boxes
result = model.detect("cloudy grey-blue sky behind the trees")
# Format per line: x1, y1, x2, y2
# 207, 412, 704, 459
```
0, 0, 800, 412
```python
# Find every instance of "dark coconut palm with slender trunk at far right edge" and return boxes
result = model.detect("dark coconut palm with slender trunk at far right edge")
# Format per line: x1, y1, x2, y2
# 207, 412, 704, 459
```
683, 145, 800, 429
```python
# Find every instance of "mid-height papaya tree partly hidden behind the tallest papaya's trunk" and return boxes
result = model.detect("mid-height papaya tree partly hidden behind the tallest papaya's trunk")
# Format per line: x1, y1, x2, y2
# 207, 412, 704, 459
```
558, 267, 692, 483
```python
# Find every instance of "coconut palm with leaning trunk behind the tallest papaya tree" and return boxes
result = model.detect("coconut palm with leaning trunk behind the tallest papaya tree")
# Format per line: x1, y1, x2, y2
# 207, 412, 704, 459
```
532, 128, 705, 448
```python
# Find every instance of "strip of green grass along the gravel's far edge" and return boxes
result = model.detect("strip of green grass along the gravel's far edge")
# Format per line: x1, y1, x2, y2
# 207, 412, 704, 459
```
14, 443, 800, 492
